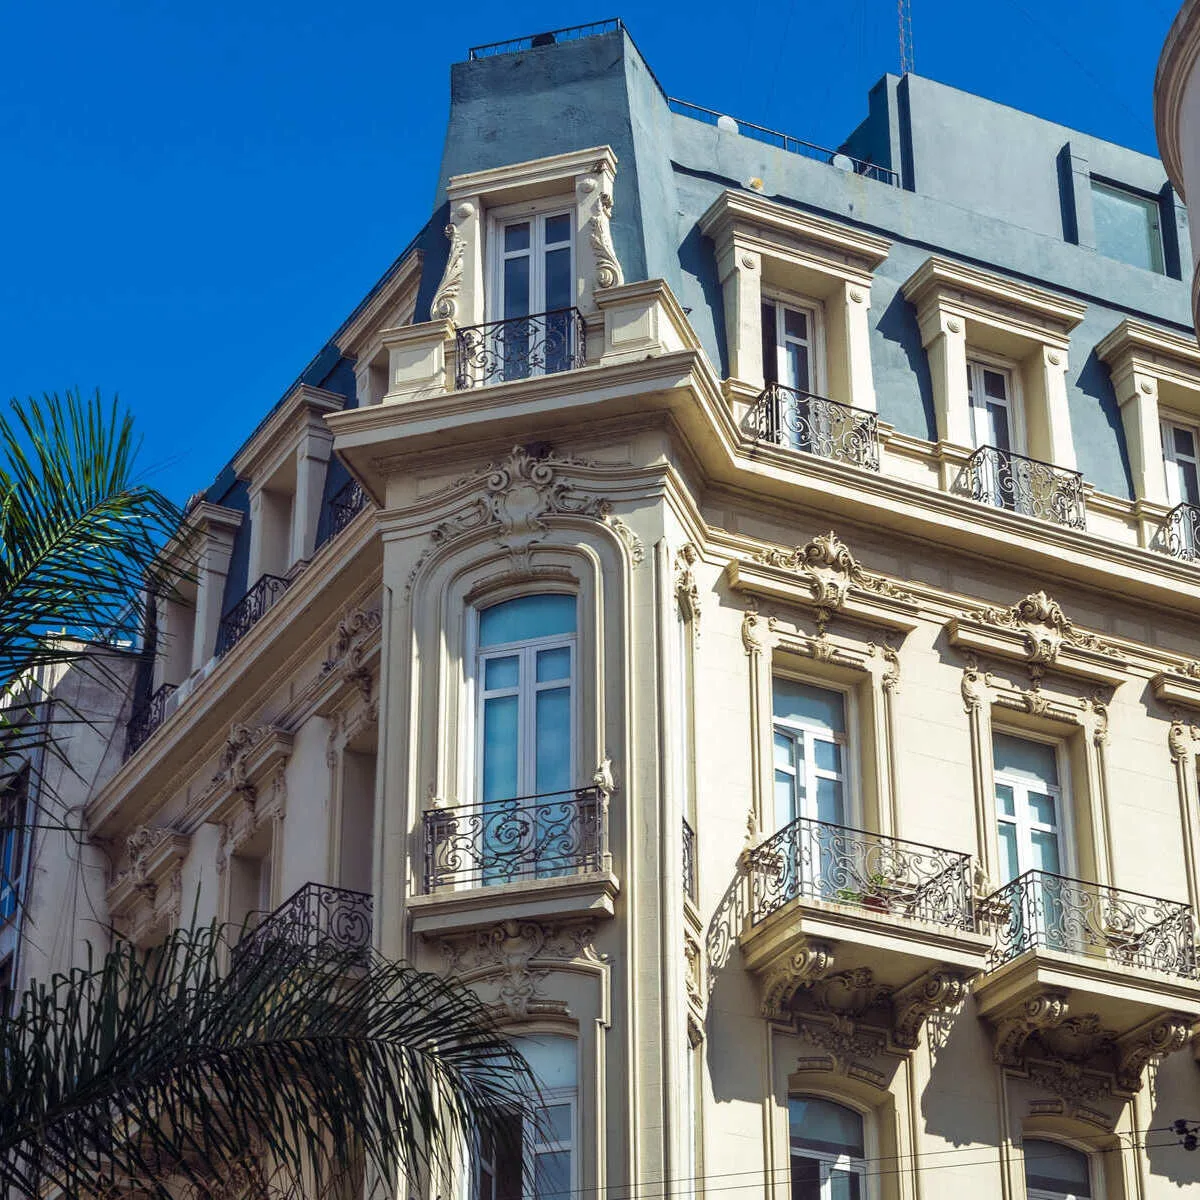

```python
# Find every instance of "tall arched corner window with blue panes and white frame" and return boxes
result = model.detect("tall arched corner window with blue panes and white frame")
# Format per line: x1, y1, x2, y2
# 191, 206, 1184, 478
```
475, 593, 576, 804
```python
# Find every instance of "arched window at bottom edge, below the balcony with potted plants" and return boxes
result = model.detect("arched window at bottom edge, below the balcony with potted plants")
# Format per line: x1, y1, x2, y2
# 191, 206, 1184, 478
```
787, 1096, 868, 1200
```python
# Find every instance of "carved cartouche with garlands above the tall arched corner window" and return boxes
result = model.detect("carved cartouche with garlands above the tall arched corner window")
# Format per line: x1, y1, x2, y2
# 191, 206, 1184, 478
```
404, 445, 646, 599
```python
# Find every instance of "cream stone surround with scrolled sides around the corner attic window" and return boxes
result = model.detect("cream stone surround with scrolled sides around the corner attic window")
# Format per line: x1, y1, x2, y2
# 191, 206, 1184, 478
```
429, 145, 624, 336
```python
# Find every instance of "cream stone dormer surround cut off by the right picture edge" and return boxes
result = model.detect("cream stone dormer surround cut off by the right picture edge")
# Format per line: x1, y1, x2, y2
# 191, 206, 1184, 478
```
1096, 318, 1200, 508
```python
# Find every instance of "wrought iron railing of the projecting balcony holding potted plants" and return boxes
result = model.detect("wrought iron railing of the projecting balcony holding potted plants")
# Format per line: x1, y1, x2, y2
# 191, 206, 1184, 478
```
749, 817, 974, 930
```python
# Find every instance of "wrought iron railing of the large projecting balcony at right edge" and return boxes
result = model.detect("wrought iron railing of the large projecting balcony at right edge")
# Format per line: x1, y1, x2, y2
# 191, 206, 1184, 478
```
980, 871, 1196, 979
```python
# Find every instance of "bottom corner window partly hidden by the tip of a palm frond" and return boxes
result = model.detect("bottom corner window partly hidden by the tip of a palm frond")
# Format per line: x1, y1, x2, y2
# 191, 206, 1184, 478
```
473, 1034, 578, 1200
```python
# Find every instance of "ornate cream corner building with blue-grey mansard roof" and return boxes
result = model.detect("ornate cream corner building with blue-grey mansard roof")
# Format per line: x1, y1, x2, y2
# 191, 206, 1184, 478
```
11, 23, 1200, 1200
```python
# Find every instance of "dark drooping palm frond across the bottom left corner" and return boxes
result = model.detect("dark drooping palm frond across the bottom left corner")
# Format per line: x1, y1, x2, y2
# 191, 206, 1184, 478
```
0, 926, 533, 1200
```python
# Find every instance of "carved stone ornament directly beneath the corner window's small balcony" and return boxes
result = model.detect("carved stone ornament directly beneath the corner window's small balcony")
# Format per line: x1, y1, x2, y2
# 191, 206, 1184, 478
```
440, 919, 607, 1019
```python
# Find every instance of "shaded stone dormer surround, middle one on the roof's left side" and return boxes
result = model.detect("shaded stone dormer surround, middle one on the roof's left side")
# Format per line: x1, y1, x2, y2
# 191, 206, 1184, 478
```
233, 384, 346, 576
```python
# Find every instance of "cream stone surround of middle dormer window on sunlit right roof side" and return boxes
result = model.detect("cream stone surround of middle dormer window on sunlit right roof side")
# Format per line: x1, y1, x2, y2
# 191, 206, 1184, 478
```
901, 254, 1086, 470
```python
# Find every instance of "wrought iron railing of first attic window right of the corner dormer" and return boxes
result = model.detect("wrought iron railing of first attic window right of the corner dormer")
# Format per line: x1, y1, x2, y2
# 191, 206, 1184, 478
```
750, 383, 880, 470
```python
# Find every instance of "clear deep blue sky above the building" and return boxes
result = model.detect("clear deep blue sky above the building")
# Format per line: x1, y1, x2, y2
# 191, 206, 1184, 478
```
0, 0, 1178, 500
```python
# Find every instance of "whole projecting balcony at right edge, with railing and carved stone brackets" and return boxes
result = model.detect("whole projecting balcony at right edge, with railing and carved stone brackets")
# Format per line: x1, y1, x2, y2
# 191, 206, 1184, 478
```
976, 871, 1200, 1091
